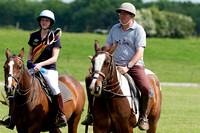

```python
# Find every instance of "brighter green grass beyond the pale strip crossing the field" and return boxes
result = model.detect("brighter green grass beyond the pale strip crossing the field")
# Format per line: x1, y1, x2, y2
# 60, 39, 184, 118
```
0, 29, 200, 83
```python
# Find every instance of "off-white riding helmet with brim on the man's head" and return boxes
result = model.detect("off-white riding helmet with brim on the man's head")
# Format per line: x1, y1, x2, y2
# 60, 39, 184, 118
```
115, 2, 136, 15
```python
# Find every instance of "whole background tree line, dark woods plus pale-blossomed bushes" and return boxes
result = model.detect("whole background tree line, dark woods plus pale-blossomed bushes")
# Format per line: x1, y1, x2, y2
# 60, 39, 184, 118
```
0, 0, 200, 38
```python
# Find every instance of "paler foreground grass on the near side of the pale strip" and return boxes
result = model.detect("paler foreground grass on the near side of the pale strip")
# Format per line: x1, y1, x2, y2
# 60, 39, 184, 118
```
0, 86, 200, 133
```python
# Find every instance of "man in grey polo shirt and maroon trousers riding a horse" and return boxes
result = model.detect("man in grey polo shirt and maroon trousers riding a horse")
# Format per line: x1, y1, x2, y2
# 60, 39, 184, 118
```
81, 2, 150, 130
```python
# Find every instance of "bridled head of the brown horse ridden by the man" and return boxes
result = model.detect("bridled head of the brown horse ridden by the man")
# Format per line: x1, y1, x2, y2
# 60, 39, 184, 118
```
89, 41, 118, 96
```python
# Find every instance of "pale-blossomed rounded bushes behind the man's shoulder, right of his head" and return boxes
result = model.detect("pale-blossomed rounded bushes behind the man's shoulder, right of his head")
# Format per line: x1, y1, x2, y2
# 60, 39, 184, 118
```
135, 7, 195, 38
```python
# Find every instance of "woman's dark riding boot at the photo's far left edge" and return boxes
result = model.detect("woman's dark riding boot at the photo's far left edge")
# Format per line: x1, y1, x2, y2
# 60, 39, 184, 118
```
0, 97, 15, 130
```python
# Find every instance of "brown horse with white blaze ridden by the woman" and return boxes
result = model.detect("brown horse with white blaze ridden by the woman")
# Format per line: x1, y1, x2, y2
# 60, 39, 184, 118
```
4, 48, 85, 133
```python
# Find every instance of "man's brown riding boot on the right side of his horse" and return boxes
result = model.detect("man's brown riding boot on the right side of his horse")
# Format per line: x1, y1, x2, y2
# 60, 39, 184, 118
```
138, 96, 150, 130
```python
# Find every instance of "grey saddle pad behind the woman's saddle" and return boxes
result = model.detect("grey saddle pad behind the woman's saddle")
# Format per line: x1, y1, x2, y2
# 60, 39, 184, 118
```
58, 81, 73, 103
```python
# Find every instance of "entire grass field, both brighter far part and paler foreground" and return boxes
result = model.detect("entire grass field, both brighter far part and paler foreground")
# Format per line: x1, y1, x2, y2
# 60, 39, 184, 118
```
0, 29, 200, 133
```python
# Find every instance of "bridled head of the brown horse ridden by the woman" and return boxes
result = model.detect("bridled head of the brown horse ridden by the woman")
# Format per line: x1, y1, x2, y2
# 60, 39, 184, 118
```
4, 48, 24, 96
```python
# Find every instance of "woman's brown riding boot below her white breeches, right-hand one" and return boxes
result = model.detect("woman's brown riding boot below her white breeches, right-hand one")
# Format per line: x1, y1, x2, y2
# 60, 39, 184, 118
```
53, 93, 67, 127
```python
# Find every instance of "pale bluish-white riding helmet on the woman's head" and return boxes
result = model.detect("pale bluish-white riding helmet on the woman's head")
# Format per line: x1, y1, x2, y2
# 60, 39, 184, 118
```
37, 10, 56, 25
